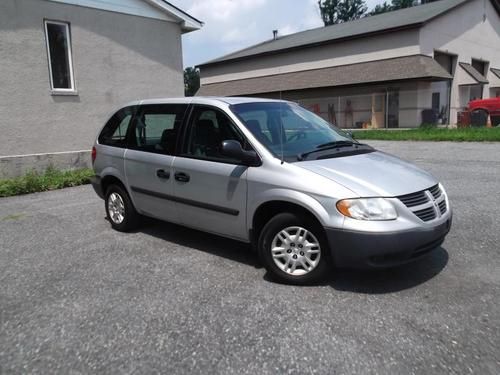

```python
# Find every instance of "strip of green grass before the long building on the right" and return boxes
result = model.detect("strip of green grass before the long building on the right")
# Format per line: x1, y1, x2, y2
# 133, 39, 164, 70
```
353, 127, 500, 142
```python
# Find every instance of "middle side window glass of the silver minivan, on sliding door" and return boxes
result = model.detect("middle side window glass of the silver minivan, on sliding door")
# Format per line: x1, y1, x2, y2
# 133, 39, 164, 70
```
131, 104, 187, 155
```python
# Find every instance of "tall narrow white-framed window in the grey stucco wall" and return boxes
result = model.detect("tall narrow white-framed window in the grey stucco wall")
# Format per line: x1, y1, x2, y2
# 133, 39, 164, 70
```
45, 21, 75, 93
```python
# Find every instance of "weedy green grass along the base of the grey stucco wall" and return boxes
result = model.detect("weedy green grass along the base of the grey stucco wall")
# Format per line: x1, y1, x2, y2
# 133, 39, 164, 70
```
0, 167, 94, 197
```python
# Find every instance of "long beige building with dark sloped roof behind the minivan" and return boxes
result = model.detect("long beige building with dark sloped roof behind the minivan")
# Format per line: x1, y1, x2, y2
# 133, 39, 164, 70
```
198, 0, 500, 128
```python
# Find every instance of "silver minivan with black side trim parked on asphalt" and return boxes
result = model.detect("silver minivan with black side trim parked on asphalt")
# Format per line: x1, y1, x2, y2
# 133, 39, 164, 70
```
92, 97, 452, 284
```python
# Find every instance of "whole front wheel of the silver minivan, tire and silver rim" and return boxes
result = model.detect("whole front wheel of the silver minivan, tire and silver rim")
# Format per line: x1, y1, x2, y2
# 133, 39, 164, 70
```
258, 213, 330, 285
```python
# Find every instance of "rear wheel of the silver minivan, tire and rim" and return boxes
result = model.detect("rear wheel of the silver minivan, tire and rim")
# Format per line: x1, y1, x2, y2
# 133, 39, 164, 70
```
104, 185, 139, 232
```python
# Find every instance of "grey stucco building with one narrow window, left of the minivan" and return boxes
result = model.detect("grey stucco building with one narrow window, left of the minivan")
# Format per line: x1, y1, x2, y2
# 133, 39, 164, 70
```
0, 0, 202, 178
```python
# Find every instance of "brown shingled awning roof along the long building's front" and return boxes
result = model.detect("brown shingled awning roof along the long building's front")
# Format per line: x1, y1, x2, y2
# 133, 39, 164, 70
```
197, 55, 453, 96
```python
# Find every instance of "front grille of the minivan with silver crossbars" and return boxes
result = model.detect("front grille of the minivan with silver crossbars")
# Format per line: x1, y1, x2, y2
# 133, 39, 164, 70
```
397, 185, 448, 222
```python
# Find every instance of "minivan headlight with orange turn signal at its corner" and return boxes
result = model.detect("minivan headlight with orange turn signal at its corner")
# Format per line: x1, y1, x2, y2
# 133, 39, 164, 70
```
337, 198, 398, 220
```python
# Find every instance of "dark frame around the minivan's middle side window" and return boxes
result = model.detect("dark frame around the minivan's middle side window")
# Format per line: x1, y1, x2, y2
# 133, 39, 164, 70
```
127, 103, 190, 156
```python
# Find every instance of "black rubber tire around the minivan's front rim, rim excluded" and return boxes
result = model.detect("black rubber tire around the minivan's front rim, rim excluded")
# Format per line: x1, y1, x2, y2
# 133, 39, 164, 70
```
258, 213, 331, 285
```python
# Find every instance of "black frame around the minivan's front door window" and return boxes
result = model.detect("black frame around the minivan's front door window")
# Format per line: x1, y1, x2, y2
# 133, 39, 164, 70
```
180, 104, 261, 165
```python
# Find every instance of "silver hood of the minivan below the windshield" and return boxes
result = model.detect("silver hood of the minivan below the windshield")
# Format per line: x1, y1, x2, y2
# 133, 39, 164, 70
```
295, 151, 438, 197
